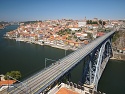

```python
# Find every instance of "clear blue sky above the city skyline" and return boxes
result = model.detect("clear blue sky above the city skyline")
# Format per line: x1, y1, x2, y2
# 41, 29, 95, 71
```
0, 0, 125, 21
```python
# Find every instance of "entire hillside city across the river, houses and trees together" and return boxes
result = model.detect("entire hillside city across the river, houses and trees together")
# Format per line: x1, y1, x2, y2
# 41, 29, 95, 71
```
5, 17, 123, 50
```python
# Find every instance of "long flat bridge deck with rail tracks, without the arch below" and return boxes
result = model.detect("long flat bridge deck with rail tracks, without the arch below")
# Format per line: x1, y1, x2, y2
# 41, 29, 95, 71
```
9, 31, 114, 94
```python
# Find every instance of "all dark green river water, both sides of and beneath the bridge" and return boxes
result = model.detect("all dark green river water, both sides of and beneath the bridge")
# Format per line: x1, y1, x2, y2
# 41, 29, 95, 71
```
0, 25, 125, 94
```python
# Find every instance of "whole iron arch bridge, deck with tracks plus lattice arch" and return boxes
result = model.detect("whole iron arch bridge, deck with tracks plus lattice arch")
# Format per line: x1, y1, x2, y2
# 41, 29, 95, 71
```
3, 31, 115, 94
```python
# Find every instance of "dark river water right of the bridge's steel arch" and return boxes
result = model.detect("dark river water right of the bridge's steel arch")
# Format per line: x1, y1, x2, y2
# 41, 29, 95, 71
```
98, 60, 125, 94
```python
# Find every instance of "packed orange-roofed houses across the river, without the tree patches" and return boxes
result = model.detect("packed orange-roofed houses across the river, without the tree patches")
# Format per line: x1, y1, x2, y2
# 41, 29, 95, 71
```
6, 19, 120, 47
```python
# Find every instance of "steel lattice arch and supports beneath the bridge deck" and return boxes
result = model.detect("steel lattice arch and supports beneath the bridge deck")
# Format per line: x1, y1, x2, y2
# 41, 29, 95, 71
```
81, 39, 112, 90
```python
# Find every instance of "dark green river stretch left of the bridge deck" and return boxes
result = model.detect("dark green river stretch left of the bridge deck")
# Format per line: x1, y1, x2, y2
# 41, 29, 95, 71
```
0, 25, 72, 78
